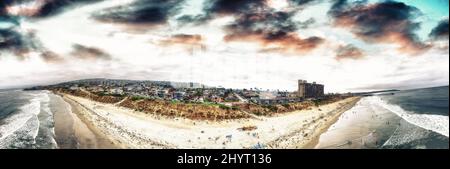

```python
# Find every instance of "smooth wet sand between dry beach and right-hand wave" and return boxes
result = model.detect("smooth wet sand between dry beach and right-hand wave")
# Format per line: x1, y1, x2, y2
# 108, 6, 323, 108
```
311, 98, 400, 149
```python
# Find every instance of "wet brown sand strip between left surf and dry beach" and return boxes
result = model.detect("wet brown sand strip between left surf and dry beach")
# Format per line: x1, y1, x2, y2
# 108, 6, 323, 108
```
50, 94, 118, 149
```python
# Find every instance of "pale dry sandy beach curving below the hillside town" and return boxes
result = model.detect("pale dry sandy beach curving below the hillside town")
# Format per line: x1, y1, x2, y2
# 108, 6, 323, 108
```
57, 94, 359, 149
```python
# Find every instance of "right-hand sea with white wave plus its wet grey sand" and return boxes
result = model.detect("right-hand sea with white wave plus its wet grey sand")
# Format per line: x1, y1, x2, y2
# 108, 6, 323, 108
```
316, 86, 449, 149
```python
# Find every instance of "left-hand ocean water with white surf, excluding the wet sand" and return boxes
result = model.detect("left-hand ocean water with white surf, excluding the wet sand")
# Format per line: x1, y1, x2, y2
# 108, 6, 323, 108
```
0, 90, 57, 149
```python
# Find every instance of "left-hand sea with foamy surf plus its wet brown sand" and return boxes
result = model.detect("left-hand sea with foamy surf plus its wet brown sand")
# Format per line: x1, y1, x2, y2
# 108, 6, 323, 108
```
0, 90, 106, 149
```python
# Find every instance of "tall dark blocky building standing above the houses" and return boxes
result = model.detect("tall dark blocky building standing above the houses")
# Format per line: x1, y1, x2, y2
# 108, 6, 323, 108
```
297, 80, 324, 98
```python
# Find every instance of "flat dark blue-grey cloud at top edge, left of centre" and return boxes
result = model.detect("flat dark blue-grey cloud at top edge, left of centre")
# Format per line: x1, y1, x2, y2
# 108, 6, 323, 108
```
93, 0, 183, 24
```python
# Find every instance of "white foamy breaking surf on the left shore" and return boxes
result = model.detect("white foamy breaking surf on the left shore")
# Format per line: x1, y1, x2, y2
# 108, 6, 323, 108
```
0, 91, 56, 148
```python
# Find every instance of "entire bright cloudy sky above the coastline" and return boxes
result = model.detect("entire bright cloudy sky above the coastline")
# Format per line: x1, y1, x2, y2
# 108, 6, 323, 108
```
0, 0, 449, 93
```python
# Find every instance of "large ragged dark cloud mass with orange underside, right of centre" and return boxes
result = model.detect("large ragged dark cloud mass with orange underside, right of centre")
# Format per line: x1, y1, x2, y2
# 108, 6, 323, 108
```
185, 0, 324, 53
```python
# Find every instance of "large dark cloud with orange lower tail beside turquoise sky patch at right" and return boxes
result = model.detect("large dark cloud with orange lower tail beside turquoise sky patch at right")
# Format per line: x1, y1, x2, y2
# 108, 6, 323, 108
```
328, 0, 429, 54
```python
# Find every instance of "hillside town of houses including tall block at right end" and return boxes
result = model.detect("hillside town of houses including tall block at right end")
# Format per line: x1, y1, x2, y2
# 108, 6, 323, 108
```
44, 79, 325, 105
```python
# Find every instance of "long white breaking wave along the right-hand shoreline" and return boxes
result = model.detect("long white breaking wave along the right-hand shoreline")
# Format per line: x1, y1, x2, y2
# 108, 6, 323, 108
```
367, 96, 449, 137
